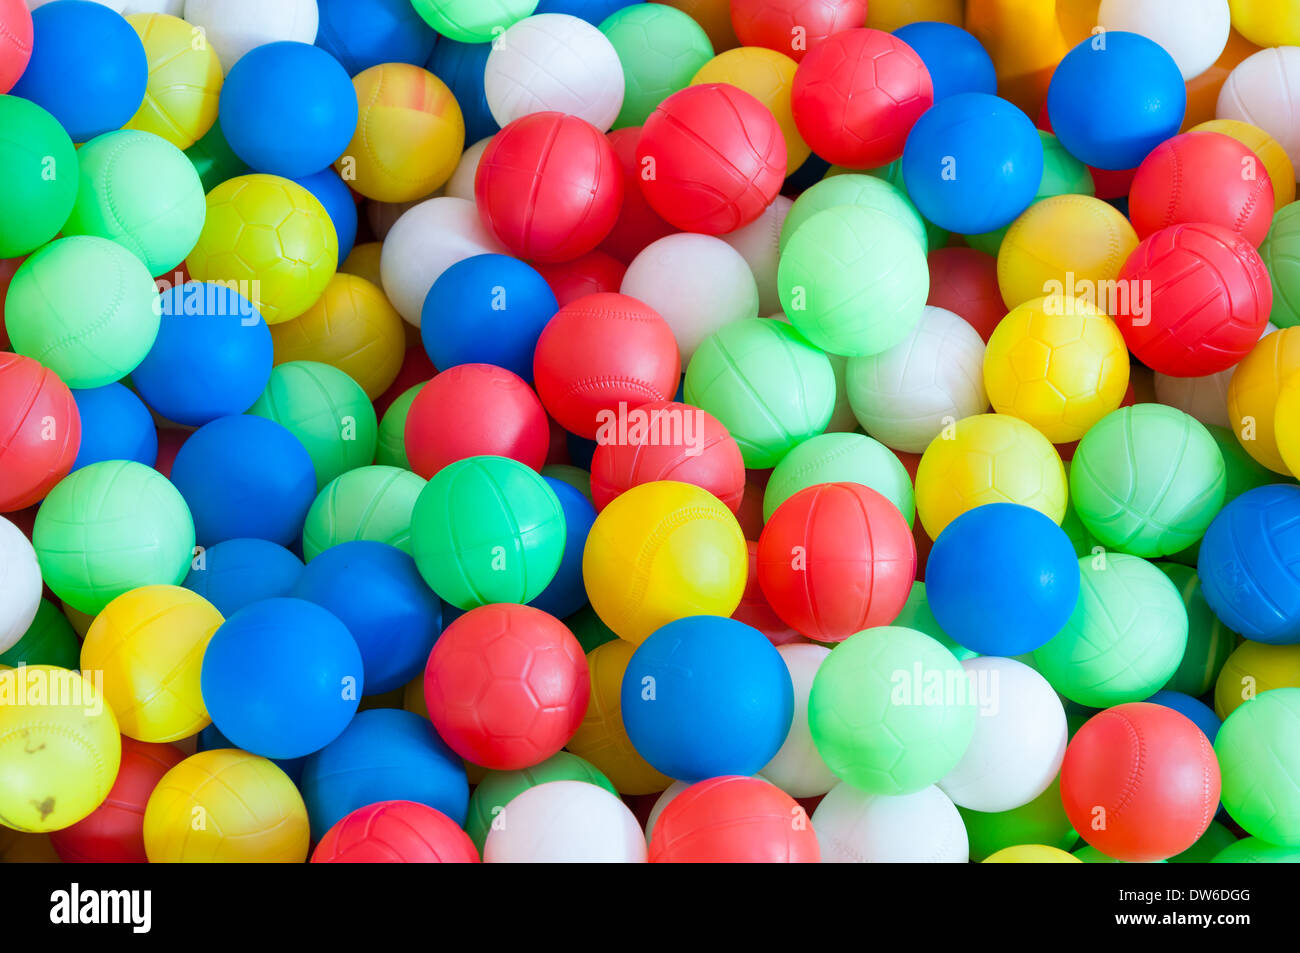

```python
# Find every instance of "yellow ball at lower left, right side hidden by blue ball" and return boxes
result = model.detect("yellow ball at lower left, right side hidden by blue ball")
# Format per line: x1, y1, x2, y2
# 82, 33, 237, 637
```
82, 585, 225, 742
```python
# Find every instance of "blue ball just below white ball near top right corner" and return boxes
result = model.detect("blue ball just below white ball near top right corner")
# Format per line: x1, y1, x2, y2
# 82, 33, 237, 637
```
1048, 30, 1187, 169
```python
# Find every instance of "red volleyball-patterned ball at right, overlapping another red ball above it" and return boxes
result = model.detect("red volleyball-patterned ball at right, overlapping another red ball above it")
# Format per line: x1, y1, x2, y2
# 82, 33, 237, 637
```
1114, 224, 1273, 377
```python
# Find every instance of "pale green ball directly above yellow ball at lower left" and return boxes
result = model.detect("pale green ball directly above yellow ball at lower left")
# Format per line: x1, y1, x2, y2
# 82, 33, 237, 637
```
33, 460, 194, 615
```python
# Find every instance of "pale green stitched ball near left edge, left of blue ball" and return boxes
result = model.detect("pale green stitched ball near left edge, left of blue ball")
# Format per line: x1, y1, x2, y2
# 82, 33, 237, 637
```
5, 235, 161, 389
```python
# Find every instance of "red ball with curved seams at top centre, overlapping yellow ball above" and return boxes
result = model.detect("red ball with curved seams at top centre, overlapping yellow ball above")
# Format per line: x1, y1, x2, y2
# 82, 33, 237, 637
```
637, 83, 785, 235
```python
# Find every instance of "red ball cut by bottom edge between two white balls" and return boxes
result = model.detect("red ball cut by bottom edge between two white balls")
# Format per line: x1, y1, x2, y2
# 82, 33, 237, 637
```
649, 775, 822, 863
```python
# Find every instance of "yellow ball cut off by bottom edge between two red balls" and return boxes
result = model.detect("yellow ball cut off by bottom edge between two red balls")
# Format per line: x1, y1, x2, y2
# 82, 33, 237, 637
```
144, 748, 311, 863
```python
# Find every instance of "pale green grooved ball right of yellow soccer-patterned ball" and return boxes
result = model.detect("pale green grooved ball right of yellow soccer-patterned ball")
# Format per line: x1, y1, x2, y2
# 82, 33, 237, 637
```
1070, 404, 1227, 556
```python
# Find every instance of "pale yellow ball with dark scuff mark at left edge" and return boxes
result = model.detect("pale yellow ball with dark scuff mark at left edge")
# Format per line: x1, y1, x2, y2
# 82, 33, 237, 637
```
0, 666, 122, 833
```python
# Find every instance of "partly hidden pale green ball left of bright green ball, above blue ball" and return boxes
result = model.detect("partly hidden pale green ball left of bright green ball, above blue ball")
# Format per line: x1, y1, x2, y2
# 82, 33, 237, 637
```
303, 467, 425, 562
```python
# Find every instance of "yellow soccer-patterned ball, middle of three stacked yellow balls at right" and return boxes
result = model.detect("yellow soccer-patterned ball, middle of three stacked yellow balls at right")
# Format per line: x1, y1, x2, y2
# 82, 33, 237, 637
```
984, 295, 1128, 443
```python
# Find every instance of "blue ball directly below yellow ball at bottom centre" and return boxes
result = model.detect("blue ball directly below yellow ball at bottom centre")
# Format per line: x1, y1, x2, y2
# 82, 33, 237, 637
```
621, 615, 794, 781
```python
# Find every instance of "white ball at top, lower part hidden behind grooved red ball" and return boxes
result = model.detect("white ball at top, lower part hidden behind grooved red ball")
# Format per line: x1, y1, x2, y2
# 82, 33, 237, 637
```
484, 13, 623, 133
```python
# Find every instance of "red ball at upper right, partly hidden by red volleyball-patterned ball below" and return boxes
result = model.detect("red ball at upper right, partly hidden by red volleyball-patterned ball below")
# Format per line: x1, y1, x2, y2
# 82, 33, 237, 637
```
1128, 133, 1273, 248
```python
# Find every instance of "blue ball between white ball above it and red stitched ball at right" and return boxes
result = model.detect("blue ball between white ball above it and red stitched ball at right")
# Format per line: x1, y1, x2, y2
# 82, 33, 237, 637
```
420, 255, 559, 382
